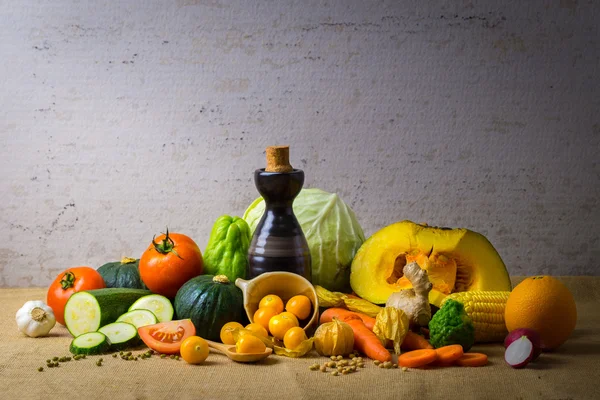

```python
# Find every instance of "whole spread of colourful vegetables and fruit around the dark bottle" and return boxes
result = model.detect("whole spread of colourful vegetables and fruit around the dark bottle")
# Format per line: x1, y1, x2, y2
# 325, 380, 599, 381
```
16, 194, 576, 375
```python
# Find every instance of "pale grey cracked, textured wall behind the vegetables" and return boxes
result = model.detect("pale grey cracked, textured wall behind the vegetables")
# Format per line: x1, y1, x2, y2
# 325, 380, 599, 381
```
0, 0, 600, 286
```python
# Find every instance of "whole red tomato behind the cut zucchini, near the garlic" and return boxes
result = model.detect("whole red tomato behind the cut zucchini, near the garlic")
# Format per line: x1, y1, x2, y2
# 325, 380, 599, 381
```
46, 267, 106, 325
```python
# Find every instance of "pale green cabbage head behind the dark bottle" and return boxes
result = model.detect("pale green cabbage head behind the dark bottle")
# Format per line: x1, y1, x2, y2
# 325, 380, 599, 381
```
244, 189, 365, 292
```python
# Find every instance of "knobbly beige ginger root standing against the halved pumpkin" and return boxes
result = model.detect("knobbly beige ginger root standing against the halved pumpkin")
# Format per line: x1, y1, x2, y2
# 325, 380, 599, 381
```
385, 262, 433, 326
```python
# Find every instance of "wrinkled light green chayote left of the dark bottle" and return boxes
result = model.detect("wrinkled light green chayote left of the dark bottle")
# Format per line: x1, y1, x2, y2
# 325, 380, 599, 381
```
204, 215, 252, 282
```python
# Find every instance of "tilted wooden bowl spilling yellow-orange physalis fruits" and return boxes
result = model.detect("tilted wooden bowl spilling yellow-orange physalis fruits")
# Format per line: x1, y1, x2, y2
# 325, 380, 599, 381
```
235, 271, 319, 330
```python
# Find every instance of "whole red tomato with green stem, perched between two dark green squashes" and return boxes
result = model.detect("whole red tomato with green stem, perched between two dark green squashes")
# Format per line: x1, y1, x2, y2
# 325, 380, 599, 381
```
140, 230, 204, 298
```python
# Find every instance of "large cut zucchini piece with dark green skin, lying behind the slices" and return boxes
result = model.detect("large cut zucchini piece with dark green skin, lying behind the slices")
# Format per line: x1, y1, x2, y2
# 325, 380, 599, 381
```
65, 288, 151, 337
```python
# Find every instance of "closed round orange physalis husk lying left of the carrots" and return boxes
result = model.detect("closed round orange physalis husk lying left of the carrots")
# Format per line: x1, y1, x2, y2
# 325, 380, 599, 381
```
314, 318, 354, 356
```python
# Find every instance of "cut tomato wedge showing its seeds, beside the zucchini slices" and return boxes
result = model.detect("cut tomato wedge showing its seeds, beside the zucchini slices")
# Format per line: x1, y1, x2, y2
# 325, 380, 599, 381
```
138, 319, 196, 354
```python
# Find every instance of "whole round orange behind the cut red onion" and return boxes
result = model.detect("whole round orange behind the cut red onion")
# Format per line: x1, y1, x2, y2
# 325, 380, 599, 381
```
504, 276, 577, 350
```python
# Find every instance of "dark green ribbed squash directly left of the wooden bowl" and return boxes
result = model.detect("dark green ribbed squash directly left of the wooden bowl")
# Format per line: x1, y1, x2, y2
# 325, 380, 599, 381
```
174, 275, 244, 341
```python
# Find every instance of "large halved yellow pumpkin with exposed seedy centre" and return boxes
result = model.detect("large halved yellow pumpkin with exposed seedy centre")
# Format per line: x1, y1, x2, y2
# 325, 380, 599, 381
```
350, 221, 511, 307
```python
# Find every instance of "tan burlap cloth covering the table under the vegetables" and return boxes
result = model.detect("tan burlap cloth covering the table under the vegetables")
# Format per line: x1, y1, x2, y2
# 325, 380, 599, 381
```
0, 277, 600, 400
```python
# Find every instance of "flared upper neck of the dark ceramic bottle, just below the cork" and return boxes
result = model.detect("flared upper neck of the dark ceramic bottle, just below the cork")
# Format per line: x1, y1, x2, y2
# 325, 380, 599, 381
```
254, 168, 304, 207
